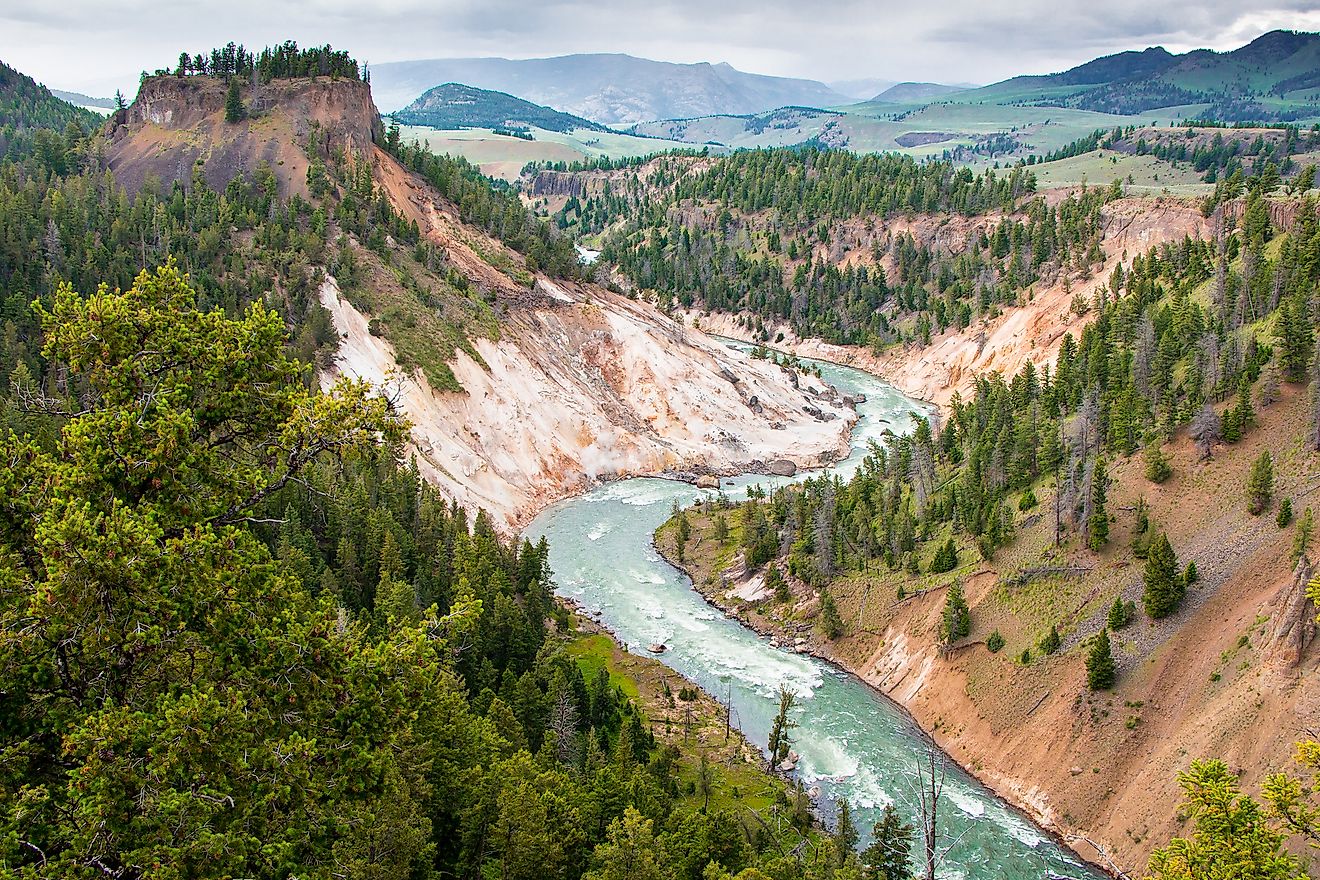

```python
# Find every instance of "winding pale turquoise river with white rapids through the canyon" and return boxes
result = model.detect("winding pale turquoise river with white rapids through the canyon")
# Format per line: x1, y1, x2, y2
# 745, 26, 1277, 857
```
525, 343, 1104, 880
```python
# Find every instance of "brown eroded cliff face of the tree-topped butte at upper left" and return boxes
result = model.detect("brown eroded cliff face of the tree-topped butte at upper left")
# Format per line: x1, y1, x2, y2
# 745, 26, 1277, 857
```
106, 77, 381, 197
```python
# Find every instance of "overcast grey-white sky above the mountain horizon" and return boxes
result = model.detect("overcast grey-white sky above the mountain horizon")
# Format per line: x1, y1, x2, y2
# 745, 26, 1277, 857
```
0, 0, 1320, 96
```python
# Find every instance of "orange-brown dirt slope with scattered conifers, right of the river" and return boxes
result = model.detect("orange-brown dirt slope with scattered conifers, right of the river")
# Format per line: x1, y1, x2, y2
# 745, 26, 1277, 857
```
675, 387, 1320, 876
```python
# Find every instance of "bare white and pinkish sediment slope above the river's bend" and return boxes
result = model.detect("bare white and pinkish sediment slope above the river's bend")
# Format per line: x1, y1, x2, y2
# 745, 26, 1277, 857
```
319, 277, 855, 530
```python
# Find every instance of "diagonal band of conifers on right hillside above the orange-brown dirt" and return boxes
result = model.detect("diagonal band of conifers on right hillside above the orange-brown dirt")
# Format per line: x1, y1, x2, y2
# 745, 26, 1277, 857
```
675, 186, 1320, 633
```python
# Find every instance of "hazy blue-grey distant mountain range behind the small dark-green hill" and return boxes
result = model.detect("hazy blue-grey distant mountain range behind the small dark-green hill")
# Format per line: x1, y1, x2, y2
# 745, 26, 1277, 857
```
371, 54, 853, 125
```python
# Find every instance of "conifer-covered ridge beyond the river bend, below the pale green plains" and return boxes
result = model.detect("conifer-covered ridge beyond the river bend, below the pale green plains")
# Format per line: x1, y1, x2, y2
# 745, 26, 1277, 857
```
561, 149, 1121, 350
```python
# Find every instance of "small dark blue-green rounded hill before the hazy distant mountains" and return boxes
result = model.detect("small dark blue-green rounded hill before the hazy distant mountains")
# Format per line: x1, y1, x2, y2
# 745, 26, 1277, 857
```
393, 83, 609, 132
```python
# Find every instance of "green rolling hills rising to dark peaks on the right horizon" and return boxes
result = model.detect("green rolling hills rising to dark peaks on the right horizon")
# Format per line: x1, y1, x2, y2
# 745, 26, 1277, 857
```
612, 30, 1320, 160
